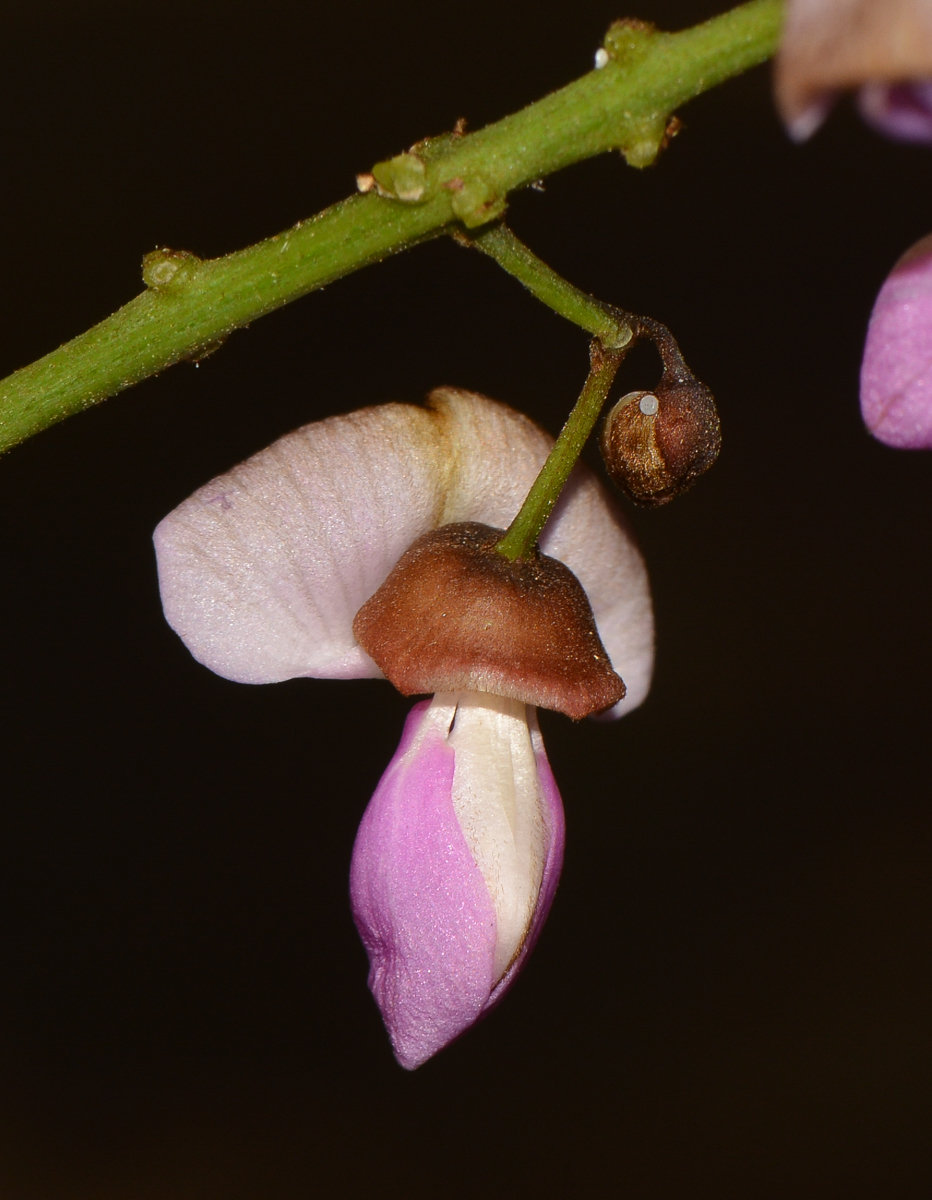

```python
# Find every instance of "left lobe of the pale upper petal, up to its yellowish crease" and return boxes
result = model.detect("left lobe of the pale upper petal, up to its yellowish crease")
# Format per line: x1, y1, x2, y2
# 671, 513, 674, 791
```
155, 404, 446, 683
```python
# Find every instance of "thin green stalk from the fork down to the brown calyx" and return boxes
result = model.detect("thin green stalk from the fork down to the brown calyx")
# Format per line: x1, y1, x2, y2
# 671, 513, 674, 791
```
495, 340, 625, 560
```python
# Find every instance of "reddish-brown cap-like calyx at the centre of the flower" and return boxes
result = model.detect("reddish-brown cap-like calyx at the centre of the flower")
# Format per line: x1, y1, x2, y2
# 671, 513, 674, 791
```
353, 522, 625, 720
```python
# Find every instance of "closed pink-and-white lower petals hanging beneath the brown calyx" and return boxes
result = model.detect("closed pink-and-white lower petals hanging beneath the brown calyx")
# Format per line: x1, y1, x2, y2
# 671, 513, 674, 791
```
350, 694, 565, 1069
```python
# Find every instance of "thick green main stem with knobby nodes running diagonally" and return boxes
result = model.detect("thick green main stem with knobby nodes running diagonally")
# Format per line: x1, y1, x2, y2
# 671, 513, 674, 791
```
0, 0, 783, 450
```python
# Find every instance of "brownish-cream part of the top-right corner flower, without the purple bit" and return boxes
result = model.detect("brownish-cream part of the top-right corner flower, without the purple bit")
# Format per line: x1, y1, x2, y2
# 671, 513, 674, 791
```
775, 0, 932, 140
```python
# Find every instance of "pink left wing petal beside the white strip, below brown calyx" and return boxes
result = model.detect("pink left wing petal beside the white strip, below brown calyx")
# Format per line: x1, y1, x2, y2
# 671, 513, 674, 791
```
350, 701, 495, 1070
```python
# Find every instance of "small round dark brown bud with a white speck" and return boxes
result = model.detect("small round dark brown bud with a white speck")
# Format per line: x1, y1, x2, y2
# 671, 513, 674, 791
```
600, 377, 722, 508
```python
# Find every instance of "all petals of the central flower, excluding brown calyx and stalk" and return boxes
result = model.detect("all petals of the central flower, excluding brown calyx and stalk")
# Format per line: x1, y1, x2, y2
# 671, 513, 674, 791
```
155, 389, 653, 1068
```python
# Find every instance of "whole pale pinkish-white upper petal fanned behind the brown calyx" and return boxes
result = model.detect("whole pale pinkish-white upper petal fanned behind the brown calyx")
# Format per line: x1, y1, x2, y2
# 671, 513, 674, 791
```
155, 388, 653, 712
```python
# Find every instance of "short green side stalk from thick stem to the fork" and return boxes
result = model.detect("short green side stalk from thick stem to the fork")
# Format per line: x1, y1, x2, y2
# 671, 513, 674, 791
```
458, 224, 633, 350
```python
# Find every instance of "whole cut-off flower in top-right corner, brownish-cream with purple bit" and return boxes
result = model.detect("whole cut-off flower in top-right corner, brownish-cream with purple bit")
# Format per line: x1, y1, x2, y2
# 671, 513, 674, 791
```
775, 0, 932, 142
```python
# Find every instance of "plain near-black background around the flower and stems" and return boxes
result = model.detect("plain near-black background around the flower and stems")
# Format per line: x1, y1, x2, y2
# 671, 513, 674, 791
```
0, 0, 932, 1200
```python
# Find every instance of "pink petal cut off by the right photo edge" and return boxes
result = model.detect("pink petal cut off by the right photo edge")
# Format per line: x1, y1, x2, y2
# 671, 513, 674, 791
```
861, 234, 932, 450
